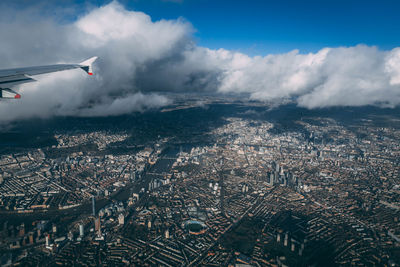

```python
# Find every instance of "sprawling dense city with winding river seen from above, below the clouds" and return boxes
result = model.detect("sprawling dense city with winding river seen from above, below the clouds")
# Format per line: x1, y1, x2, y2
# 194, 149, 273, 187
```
0, 101, 400, 266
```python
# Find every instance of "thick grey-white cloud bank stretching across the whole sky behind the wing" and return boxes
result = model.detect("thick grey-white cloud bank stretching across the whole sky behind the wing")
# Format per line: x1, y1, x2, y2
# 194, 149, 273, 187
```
0, 2, 400, 122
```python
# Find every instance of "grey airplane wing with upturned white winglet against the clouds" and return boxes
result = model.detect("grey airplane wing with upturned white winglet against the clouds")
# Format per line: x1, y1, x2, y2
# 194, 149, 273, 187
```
0, 57, 97, 99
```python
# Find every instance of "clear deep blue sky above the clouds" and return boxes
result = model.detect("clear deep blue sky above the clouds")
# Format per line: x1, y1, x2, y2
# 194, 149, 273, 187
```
121, 0, 400, 54
